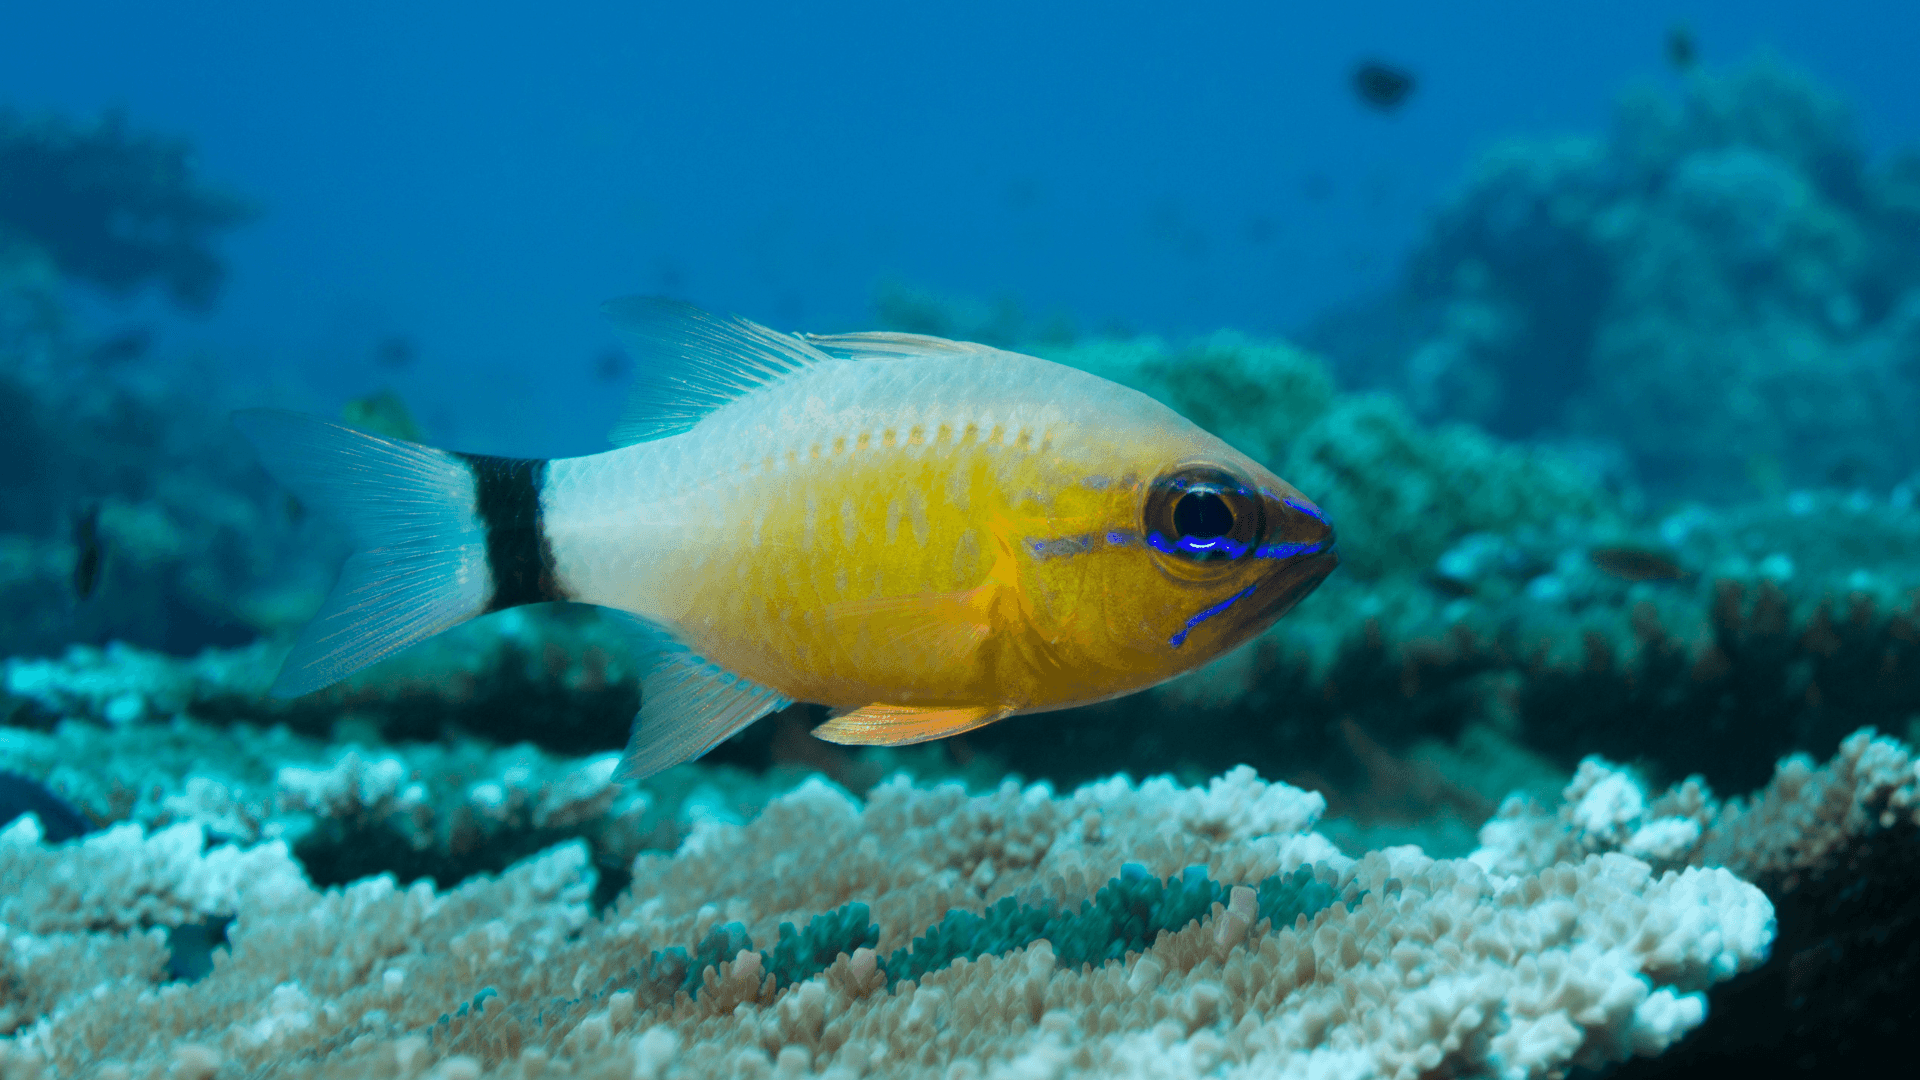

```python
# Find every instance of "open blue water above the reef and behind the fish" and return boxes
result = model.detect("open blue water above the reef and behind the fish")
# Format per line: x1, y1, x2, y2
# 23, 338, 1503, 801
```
0, 0, 1920, 454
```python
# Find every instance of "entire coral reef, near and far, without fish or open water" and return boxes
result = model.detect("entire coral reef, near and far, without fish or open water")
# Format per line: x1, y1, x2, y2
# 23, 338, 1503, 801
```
0, 14, 1920, 1078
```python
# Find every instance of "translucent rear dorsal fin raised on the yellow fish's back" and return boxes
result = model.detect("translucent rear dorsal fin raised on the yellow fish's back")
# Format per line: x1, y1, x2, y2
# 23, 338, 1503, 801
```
601, 296, 833, 446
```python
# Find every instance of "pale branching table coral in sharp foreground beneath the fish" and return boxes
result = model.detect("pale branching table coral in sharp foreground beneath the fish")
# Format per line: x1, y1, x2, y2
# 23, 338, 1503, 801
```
0, 759, 1772, 1080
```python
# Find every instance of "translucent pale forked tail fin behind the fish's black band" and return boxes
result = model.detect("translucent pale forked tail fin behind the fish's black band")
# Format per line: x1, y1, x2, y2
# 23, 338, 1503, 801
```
232, 409, 506, 698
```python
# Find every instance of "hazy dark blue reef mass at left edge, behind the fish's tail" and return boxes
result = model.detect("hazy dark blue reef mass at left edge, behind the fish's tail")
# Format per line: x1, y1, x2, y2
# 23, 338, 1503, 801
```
0, 110, 314, 655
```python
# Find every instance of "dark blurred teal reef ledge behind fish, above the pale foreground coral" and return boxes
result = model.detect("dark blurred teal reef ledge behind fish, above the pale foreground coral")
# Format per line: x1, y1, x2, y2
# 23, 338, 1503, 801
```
15, 474, 1920, 853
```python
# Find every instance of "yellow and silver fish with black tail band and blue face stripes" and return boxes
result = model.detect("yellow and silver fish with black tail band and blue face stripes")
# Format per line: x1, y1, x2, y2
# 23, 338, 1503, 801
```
234, 298, 1338, 778
